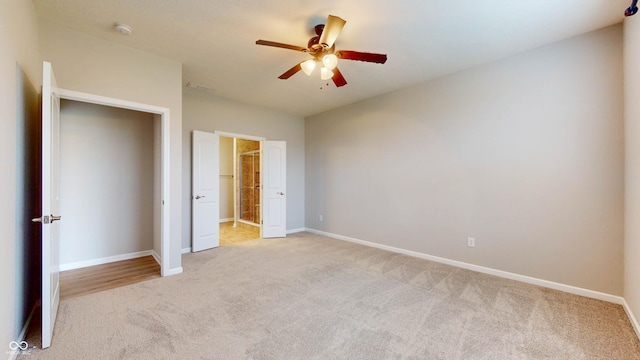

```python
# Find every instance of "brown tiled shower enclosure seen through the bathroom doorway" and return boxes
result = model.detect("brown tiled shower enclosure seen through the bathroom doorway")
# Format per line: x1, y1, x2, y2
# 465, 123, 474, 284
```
238, 150, 260, 224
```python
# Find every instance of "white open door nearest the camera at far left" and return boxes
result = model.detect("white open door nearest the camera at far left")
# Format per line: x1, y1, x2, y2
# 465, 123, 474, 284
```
33, 62, 60, 349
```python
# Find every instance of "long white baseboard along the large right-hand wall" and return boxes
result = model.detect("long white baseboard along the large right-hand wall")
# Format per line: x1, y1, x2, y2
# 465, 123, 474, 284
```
306, 228, 625, 305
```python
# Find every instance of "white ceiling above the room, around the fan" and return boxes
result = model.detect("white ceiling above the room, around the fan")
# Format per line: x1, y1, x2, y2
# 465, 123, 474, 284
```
33, 0, 630, 116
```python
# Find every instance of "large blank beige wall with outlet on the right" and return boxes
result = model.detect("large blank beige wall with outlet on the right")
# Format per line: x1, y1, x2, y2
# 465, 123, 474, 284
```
305, 26, 624, 295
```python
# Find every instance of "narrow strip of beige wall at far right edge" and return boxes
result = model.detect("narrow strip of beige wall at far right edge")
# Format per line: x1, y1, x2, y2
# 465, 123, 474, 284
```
624, 15, 640, 331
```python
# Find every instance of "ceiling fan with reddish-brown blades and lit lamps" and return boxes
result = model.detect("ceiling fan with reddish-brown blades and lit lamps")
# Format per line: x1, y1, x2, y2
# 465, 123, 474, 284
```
256, 15, 387, 87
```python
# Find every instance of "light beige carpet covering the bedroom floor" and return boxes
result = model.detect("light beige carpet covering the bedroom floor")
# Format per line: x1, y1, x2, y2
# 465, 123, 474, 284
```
21, 233, 640, 360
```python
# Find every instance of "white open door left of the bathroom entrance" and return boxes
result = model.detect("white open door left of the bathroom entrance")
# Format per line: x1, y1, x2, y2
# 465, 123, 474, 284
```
191, 131, 220, 252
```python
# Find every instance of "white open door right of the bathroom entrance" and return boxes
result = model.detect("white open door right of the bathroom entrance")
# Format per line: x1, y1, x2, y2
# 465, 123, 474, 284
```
261, 141, 287, 238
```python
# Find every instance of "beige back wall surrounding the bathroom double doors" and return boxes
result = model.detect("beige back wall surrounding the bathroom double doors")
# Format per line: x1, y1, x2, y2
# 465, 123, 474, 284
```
182, 88, 305, 249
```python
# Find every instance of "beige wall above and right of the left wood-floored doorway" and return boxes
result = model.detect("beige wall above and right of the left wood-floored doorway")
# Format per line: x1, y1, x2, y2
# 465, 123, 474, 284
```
40, 21, 182, 271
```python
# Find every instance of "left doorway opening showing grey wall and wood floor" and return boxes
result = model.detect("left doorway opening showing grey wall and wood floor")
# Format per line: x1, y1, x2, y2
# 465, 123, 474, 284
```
60, 99, 160, 296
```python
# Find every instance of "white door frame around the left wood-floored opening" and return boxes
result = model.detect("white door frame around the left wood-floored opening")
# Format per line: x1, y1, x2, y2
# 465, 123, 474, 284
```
56, 89, 172, 276
